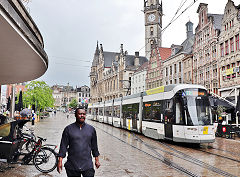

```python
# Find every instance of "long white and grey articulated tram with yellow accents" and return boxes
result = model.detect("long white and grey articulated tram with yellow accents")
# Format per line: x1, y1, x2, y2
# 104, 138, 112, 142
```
88, 84, 215, 144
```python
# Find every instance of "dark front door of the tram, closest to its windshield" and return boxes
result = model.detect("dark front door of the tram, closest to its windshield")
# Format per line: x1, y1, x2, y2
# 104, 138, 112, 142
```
164, 100, 174, 140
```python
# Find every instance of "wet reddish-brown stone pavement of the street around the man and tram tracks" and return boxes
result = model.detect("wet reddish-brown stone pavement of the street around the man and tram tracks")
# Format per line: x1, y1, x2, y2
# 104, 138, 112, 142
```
0, 112, 240, 177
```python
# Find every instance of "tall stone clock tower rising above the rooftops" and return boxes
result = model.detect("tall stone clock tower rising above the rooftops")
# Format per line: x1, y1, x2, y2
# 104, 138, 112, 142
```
144, 0, 163, 59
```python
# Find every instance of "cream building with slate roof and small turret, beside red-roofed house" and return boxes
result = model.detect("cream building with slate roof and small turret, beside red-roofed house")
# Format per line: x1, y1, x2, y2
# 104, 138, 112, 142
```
162, 21, 194, 85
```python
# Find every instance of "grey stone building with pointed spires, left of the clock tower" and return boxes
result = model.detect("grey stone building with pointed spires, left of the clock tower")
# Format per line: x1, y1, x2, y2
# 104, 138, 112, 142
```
90, 44, 147, 103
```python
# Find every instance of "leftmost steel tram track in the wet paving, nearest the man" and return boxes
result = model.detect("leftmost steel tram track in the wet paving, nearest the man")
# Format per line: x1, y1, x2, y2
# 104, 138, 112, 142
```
95, 124, 200, 177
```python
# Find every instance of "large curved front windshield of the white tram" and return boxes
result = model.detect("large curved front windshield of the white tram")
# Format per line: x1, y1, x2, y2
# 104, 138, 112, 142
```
182, 89, 212, 125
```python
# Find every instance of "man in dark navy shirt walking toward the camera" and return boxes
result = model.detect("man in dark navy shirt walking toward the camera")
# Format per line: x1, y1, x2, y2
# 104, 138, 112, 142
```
57, 108, 100, 177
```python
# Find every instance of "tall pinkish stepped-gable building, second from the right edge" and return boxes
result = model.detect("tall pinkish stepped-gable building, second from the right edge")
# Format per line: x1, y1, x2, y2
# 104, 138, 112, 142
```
193, 3, 223, 93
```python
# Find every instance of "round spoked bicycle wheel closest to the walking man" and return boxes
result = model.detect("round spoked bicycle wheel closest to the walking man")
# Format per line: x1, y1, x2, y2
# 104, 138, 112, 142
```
33, 147, 58, 173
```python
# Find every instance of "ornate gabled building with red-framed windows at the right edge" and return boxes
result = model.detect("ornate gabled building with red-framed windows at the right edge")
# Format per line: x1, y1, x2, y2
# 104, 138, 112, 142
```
219, 0, 240, 100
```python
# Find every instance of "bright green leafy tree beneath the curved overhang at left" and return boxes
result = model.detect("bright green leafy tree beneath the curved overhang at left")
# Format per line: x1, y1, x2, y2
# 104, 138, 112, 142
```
23, 81, 54, 110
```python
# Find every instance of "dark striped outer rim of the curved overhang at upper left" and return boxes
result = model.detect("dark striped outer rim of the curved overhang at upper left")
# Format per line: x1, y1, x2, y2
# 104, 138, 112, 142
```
0, 0, 48, 65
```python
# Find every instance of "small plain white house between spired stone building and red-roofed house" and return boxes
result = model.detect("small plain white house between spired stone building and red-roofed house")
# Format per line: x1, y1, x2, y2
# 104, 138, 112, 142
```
131, 62, 148, 94
